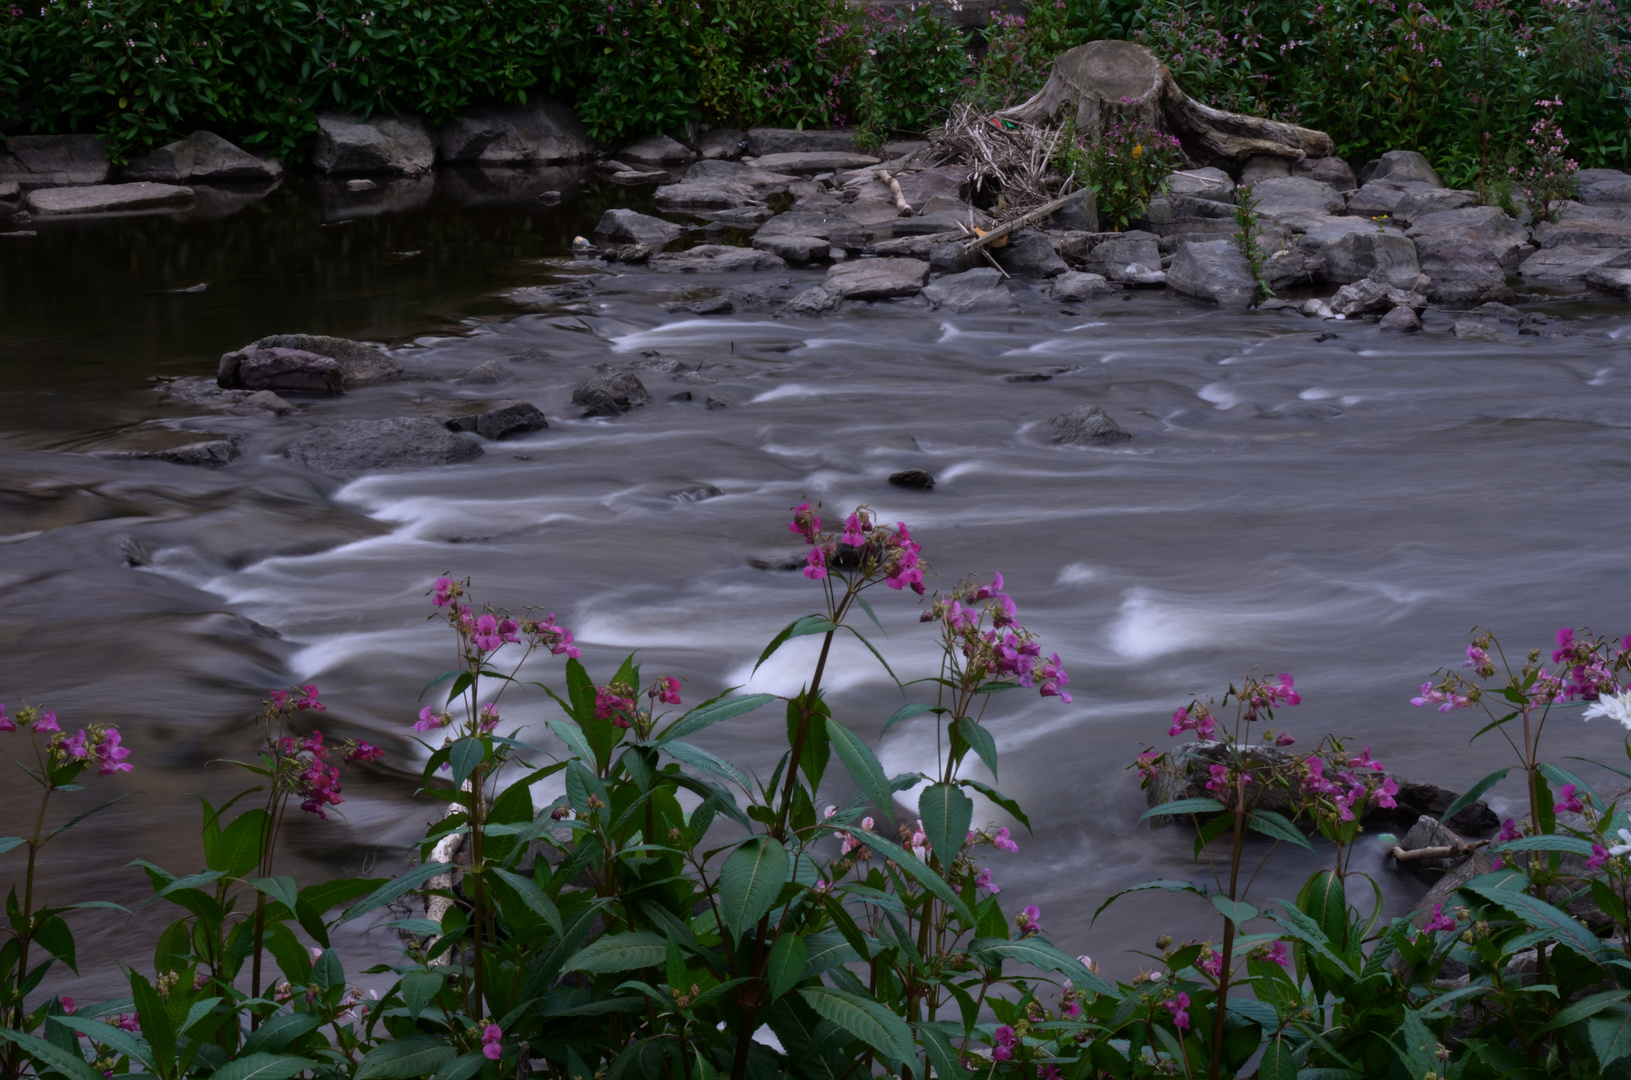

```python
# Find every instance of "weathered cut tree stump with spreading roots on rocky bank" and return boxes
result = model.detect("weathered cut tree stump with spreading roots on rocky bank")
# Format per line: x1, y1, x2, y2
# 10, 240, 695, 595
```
998, 41, 1336, 165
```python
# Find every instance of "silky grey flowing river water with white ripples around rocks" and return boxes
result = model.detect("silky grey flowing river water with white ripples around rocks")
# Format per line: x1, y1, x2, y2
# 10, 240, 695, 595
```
0, 173, 1631, 992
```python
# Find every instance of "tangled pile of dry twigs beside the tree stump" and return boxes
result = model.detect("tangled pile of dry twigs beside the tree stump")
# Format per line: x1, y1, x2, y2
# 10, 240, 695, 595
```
930, 103, 1080, 217
